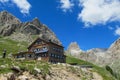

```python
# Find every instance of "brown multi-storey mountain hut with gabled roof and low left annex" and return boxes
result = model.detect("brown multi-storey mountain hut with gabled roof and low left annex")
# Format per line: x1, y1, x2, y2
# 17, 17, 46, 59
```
14, 38, 66, 63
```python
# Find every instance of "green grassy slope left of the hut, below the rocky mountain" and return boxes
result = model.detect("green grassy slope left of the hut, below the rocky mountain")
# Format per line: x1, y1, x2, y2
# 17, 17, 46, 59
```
0, 36, 28, 54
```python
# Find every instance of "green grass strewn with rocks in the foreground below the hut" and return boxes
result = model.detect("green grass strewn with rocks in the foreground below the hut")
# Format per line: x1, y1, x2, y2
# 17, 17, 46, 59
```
0, 58, 50, 75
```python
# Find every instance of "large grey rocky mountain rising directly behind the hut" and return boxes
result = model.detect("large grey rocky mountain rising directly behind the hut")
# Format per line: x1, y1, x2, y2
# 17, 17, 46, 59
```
0, 11, 61, 45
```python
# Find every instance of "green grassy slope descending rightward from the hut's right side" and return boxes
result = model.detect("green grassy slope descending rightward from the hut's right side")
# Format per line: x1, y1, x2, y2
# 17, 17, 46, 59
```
66, 56, 115, 80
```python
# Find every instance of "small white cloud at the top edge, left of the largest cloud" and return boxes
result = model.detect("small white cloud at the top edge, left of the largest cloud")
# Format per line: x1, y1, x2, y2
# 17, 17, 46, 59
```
60, 0, 74, 12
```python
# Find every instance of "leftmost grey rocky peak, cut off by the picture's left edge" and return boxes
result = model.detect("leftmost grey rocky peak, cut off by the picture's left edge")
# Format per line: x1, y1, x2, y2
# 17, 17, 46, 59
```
0, 11, 20, 36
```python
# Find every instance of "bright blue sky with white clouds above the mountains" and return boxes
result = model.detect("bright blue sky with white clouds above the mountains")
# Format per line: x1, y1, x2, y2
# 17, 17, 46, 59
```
0, 0, 120, 50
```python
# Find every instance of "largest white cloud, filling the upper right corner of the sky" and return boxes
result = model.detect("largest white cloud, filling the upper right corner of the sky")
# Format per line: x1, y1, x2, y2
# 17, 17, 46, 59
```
78, 0, 120, 25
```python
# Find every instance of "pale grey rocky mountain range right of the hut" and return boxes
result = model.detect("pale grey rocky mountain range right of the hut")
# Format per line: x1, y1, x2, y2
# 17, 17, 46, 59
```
68, 38, 120, 66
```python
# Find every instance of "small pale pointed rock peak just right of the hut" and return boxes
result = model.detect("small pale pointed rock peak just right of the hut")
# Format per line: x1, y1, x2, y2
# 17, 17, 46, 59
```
67, 42, 82, 57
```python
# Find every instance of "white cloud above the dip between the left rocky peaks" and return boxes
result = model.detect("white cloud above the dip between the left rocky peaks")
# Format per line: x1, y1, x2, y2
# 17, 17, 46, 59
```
12, 0, 31, 14
